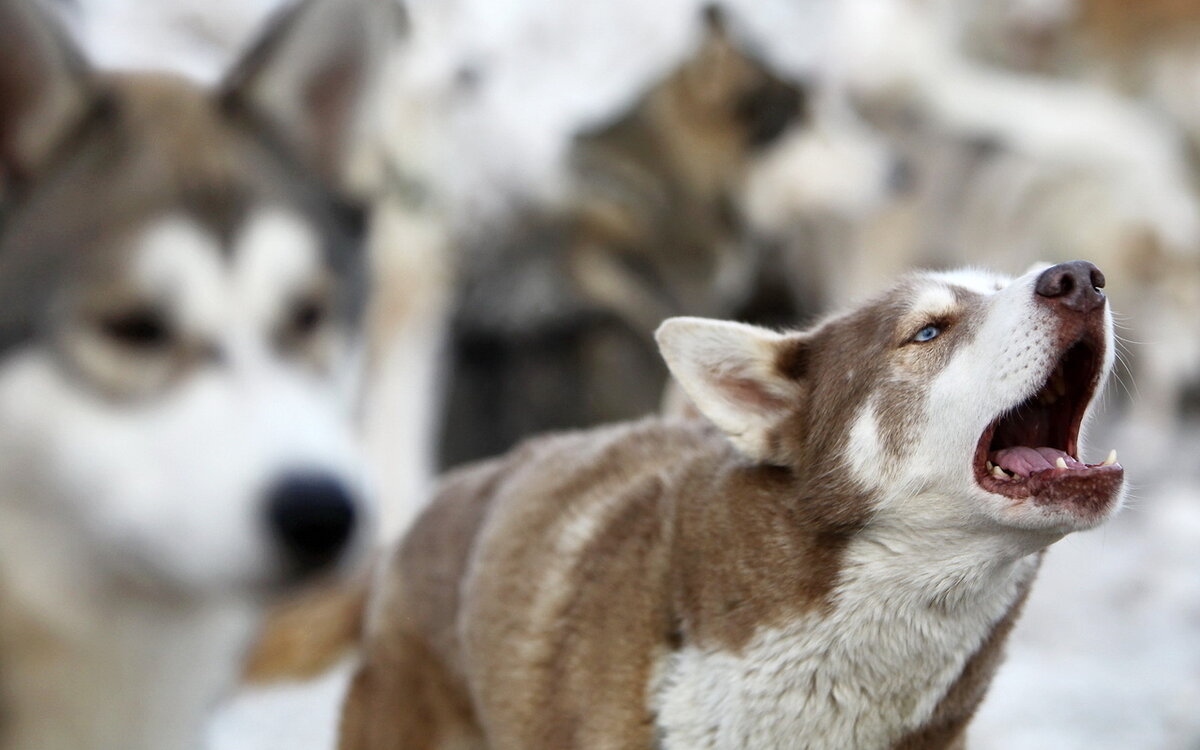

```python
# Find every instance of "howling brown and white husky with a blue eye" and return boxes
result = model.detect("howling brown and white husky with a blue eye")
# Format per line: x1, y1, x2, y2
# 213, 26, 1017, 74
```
342, 262, 1124, 750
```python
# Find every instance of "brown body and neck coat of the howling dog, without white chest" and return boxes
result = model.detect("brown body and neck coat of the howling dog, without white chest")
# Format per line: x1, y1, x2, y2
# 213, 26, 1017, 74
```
342, 420, 883, 749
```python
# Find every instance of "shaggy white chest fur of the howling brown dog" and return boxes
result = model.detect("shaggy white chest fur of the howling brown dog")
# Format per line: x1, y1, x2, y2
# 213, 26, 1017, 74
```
650, 532, 1036, 750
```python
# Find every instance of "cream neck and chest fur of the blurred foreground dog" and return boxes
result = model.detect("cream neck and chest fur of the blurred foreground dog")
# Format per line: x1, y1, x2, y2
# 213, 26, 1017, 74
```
0, 503, 257, 750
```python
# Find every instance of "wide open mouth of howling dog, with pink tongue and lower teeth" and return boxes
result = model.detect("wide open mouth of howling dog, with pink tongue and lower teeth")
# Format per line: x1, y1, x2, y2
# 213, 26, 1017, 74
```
974, 338, 1124, 503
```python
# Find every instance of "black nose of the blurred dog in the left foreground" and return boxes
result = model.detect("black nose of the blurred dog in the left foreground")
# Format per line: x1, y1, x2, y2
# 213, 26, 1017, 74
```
266, 474, 358, 575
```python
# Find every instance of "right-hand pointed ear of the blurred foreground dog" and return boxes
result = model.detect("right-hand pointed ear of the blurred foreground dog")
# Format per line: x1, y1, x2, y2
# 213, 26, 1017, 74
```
220, 0, 408, 187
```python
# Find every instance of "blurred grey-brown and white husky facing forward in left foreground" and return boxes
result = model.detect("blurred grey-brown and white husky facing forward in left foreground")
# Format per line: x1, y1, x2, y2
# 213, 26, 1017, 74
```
0, 0, 402, 750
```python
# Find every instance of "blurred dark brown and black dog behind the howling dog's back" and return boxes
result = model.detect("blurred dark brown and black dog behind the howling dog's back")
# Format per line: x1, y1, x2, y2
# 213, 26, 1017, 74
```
440, 7, 805, 467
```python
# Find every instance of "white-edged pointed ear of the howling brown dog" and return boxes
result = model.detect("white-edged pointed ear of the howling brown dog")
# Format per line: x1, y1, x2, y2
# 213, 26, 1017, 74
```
654, 318, 805, 463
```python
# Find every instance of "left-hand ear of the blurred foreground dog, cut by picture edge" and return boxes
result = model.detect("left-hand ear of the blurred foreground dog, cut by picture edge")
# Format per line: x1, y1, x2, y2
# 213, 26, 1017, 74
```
0, 0, 91, 186
